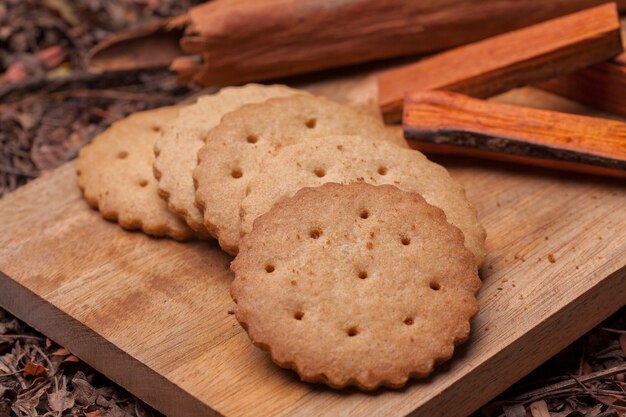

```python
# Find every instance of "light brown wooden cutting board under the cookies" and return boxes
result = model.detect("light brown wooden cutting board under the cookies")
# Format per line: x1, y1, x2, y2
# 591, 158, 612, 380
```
0, 78, 626, 417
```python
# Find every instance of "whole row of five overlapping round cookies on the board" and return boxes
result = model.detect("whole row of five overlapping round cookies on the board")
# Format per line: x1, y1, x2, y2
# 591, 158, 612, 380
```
76, 85, 485, 390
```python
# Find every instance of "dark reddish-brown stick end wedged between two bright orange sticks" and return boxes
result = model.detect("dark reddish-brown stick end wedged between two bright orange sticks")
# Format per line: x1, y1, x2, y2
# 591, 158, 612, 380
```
537, 54, 626, 116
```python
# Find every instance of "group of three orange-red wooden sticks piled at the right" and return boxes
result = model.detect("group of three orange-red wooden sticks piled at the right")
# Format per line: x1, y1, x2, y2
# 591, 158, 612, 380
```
378, 4, 626, 178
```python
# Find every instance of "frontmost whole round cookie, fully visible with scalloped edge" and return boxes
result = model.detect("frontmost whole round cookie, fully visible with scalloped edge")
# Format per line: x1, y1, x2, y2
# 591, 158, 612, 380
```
231, 183, 481, 390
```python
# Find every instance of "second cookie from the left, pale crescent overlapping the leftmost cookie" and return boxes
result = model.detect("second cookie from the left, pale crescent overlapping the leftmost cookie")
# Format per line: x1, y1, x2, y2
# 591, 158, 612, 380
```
154, 84, 303, 236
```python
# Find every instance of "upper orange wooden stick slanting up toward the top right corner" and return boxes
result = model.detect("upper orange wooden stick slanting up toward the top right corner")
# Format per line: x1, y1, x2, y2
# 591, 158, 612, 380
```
378, 4, 622, 122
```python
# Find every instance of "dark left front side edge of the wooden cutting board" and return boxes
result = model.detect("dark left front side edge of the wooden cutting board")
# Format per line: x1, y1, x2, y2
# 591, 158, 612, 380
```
0, 271, 221, 417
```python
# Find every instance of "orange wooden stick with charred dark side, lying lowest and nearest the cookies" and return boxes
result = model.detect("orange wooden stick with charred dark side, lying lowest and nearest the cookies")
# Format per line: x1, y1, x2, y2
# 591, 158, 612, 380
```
403, 91, 626, 177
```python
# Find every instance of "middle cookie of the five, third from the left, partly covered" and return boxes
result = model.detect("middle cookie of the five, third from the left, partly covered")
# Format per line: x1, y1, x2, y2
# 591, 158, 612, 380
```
193, 95, 407, 254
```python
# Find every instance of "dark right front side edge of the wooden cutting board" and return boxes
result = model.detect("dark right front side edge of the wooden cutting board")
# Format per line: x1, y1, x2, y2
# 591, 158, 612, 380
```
409, 264, 626, 417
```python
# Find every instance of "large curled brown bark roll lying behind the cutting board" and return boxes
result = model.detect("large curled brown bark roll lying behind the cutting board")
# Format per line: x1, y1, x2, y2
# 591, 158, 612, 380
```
89, 0, 626, 86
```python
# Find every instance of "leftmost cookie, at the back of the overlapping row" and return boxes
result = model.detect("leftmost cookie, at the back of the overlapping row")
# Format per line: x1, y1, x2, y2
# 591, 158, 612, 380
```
76, 107, 195, 240
